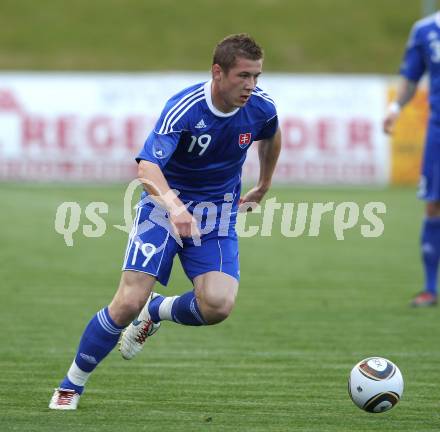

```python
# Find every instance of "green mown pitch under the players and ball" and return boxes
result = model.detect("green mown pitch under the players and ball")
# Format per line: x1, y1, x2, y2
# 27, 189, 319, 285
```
0, 184, 440, 432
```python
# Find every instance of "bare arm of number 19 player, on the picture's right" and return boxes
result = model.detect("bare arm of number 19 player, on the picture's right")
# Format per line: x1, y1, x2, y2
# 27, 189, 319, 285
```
240, 128, 281, 210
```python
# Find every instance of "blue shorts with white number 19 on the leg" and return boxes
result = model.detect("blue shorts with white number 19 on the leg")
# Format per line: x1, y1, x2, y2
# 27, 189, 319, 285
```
122, 205, 240, 285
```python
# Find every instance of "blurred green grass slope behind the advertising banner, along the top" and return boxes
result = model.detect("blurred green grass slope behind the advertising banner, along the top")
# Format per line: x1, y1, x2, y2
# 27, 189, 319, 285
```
0, 0, 422, 74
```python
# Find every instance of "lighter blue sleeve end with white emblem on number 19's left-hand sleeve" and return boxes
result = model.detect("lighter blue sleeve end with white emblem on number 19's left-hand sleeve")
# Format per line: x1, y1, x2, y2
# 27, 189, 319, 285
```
136, 131, 180, 168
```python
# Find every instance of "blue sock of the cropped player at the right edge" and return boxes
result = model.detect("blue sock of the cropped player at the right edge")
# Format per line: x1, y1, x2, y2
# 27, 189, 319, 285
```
421, 218, 440, 295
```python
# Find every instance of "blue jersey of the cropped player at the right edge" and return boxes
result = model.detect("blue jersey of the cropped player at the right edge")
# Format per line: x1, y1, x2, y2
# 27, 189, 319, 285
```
400, 12, 440, 121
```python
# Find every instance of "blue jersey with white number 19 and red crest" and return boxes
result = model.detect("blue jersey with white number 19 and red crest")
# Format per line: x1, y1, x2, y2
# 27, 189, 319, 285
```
136, 81, 278, 202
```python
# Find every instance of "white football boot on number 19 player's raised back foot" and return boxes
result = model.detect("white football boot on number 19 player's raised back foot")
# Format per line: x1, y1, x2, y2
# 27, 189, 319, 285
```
119, 292, 160, 360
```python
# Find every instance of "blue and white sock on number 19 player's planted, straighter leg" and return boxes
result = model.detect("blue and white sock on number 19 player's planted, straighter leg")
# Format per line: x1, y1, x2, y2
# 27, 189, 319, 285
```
60, 307, 124, 394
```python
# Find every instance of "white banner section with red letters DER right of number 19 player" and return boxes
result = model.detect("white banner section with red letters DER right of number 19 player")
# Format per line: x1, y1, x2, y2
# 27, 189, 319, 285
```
246, 75, 390, 184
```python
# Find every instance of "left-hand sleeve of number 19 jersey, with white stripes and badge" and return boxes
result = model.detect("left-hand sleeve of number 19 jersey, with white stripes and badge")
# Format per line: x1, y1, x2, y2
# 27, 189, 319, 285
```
136, 102, 184, 168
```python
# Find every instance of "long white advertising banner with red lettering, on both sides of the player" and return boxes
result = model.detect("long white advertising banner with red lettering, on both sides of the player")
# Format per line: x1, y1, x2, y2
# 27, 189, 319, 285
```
0, 73, 391, 184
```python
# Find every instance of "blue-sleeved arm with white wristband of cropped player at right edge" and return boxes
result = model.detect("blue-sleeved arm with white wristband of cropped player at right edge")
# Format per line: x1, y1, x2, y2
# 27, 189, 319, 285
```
383, 19, 426, 134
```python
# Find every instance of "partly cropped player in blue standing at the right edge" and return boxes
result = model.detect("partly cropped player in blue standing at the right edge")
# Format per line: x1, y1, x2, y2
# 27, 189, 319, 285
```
384, 12, 440, 307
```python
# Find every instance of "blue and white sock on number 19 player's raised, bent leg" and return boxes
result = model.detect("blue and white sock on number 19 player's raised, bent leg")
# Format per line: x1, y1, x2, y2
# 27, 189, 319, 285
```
148, 291, 206, 326
